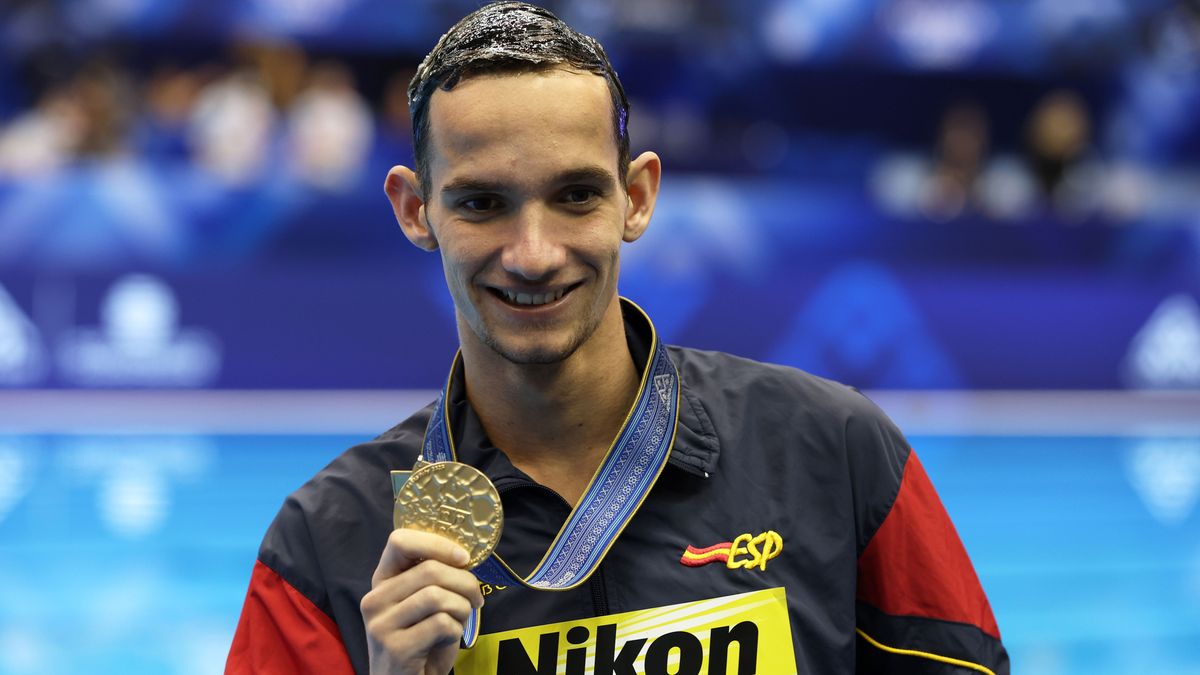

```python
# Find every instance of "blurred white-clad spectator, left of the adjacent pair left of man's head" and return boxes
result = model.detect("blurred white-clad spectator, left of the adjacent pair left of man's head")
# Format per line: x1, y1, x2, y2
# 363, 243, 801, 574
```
188, 70, 275, 185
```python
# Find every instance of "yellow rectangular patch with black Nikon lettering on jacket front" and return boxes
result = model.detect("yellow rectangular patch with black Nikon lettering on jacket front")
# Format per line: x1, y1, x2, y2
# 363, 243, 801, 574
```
454, 589, 796, 675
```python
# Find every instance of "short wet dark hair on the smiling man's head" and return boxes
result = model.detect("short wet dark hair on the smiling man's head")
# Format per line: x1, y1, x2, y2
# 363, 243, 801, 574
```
408, 2, 629, 198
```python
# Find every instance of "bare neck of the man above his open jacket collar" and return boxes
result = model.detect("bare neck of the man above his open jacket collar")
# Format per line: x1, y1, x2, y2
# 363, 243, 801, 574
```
462, 299, 641, 503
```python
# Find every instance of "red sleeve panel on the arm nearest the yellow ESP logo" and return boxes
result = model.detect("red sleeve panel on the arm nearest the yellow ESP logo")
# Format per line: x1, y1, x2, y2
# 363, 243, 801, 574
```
858, 453, 1000, 640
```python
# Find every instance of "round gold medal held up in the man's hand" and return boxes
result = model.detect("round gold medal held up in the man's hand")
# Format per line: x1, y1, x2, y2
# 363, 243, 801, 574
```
391, 460, 504, 569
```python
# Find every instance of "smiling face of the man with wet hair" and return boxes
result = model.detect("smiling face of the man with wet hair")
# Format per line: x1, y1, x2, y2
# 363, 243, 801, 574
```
408, 70, 656, 364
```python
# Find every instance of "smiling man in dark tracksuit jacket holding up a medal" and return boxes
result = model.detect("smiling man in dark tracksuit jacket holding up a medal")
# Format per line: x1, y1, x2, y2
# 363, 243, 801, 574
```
227, 2, 1008, 675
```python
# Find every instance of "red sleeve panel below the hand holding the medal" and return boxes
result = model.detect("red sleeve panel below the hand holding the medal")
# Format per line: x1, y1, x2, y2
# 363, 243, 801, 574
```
226, 561, 354, 675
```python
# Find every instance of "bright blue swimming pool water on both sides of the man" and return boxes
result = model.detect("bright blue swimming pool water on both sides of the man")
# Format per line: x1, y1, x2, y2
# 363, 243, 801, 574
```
0, 434, 1200, 675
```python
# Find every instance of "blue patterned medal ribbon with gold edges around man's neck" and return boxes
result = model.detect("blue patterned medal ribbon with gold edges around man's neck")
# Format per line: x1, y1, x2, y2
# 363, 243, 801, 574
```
421, 298, 679, 647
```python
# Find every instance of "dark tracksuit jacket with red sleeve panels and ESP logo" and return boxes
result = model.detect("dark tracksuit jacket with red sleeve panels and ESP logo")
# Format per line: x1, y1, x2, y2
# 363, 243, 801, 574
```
227, 317, 1008, 675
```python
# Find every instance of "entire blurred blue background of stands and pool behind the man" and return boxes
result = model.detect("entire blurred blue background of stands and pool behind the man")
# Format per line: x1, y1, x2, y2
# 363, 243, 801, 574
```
0, 0, 1200, 675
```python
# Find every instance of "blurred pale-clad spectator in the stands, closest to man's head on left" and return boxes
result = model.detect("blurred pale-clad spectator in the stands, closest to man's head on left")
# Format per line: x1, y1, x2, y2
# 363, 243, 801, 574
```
288, 62, 374, 190
